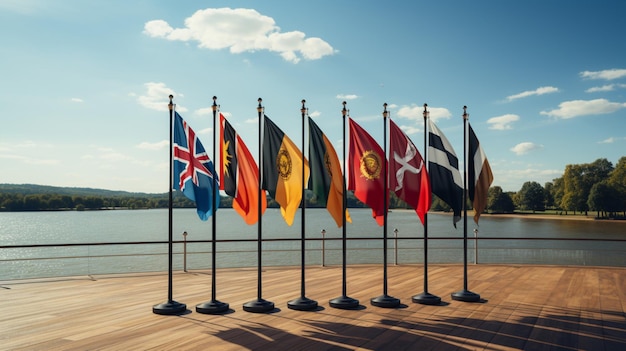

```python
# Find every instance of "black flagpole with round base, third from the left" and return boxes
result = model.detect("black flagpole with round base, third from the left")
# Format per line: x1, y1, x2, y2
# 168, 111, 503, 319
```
243, 98, 274, 313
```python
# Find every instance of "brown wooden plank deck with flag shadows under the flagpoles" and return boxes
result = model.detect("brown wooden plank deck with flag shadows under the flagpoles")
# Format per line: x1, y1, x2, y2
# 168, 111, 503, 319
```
0, 265, 626, 351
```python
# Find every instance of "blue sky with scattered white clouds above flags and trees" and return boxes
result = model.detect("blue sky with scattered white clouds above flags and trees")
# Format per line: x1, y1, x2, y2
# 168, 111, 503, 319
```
0, 0, 626, 193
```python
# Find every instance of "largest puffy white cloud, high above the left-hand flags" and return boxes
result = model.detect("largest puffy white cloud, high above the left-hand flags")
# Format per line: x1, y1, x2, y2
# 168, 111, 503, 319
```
143, 8, 336, 63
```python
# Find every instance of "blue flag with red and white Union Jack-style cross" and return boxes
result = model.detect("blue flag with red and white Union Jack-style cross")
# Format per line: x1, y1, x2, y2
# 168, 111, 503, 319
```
172, 111, 220, 221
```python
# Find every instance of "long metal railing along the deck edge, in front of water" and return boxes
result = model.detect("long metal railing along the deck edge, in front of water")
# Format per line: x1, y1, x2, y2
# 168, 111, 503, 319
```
0, 235, 626, 280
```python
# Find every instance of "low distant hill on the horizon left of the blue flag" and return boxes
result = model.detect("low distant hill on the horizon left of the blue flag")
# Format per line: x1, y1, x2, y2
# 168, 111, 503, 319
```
0, 184, 167, 197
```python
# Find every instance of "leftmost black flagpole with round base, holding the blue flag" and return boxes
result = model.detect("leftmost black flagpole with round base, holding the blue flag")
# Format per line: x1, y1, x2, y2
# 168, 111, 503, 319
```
152, 95, 187, 315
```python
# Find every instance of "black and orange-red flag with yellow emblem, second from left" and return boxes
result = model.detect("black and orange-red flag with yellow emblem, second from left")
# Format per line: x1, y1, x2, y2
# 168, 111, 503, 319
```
220, 113, 267, 224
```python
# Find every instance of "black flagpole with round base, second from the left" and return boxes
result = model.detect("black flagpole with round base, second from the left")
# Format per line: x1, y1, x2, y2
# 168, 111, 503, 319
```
196, 96, 229, 314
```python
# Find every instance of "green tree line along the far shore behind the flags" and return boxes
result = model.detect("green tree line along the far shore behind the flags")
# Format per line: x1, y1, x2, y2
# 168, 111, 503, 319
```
0, 157, 626, 219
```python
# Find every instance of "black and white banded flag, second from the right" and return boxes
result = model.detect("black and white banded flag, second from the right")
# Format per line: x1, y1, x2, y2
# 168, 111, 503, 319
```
428, 119, 463, 228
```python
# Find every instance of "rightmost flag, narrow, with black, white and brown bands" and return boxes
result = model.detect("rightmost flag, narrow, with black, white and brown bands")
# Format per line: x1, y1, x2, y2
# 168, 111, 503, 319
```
467, 123, 493, 224
